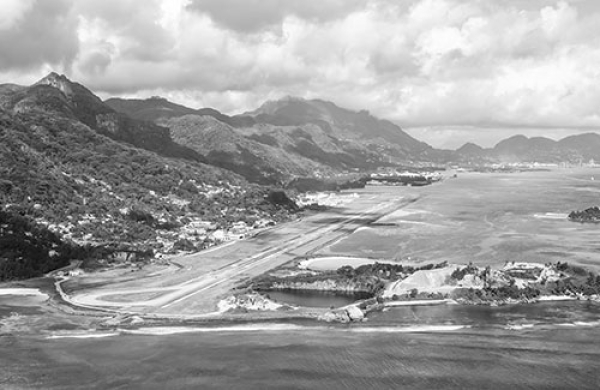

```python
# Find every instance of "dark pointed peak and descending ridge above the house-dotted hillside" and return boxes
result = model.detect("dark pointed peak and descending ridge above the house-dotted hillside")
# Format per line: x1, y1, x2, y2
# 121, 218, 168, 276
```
0, 72, 203, 161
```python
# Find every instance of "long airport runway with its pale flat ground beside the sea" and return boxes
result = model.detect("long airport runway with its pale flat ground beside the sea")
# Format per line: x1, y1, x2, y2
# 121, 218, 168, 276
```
63, 194, 410, 316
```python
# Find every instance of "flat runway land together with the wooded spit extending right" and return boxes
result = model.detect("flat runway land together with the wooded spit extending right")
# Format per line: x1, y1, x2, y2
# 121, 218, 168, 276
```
24, 187, 600, 328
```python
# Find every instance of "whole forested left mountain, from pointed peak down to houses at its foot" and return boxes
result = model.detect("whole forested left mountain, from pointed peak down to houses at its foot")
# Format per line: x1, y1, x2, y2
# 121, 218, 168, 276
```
0, 75, 294, 280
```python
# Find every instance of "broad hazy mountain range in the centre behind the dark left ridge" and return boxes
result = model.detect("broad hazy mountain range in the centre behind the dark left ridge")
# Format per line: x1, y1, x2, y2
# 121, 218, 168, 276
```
106, 98, 442, 183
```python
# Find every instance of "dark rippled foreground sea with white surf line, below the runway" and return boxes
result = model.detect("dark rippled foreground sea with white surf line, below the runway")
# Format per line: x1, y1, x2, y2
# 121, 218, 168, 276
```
0, 302, 600, 390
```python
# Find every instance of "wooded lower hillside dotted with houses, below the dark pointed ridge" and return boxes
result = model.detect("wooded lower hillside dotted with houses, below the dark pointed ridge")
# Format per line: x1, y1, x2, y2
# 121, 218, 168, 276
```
0, 106, 296, 279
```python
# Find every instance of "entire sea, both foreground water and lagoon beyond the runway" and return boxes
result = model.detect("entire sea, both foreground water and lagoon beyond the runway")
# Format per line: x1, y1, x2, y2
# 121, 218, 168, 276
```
0, 170, 600, 390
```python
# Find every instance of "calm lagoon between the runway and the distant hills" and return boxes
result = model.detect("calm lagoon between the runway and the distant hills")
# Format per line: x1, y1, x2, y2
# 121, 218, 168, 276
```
322, 168, 600, 271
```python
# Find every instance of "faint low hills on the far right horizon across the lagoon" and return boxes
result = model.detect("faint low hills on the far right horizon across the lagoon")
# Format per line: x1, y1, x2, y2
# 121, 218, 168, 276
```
456, 133, 600, 163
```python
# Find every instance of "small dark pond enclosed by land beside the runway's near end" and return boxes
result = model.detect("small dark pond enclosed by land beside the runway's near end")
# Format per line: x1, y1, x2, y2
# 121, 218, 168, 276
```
262, 290, 371, 307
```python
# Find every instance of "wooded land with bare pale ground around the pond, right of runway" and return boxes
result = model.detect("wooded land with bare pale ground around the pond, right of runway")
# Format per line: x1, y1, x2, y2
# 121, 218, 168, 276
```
226, 258, 600, 323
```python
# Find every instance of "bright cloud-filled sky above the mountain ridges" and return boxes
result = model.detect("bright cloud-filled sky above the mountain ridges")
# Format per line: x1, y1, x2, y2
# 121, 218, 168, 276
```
0, 0, 600, 148
